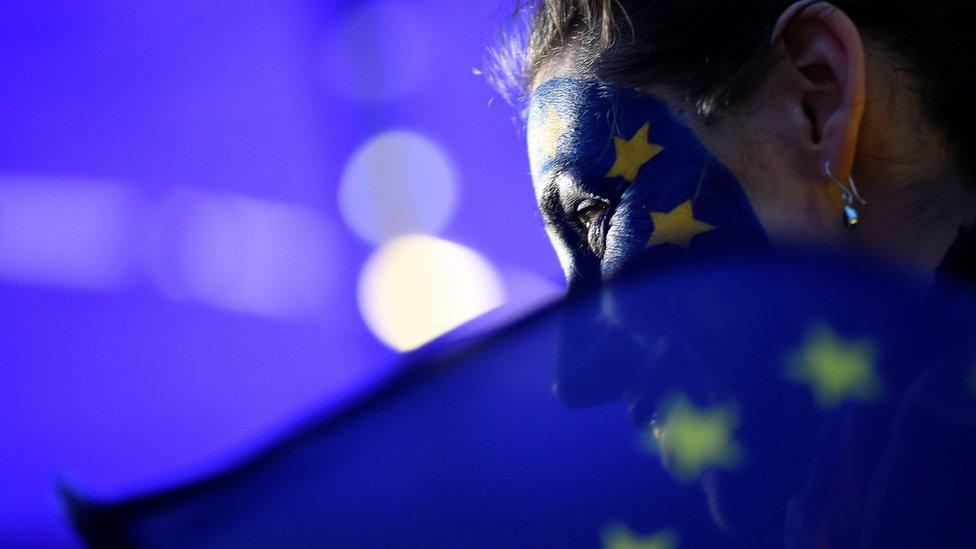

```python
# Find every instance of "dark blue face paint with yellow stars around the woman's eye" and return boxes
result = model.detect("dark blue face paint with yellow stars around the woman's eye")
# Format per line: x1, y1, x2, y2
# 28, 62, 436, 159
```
528, 77, 766, 279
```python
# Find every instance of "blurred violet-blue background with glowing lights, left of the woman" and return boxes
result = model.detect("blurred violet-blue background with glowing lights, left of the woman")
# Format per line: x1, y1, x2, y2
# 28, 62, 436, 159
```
0, 0, 562, 546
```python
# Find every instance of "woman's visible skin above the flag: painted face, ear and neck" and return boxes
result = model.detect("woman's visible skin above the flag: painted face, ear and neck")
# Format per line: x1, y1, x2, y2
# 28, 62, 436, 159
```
528, 2, 976, 284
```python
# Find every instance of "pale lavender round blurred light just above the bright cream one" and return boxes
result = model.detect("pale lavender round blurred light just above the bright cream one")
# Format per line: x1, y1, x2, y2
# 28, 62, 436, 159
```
339, 131, 457, 244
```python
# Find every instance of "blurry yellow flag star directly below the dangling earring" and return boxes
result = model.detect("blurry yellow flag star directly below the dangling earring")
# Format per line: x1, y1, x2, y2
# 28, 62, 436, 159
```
787, 324, 882, 408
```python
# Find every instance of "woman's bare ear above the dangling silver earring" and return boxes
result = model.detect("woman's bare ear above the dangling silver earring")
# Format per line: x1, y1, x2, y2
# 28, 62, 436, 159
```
772, 0, 866, 180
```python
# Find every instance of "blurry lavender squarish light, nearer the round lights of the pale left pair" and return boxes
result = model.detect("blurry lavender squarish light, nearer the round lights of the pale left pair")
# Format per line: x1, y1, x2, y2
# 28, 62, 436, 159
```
153, 191, 334, 318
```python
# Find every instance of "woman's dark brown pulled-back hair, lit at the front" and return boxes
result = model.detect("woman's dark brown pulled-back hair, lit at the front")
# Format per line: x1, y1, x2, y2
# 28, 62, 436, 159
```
494, 0, 976, 173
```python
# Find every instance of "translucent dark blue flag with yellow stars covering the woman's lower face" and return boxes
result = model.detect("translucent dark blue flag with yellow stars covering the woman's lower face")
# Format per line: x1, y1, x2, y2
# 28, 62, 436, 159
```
70, 250, 976, 549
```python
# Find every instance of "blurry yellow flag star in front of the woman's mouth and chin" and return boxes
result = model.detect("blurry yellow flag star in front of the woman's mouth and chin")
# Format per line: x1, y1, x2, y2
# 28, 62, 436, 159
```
651, 397, 742, 480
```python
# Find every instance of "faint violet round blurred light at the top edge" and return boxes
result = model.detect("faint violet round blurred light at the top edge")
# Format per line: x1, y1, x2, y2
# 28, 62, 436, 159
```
324, 0, 431, 101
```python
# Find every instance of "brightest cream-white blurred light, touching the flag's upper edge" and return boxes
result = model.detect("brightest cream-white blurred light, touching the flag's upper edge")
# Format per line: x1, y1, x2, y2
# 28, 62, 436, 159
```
358, 235, 505, 351
